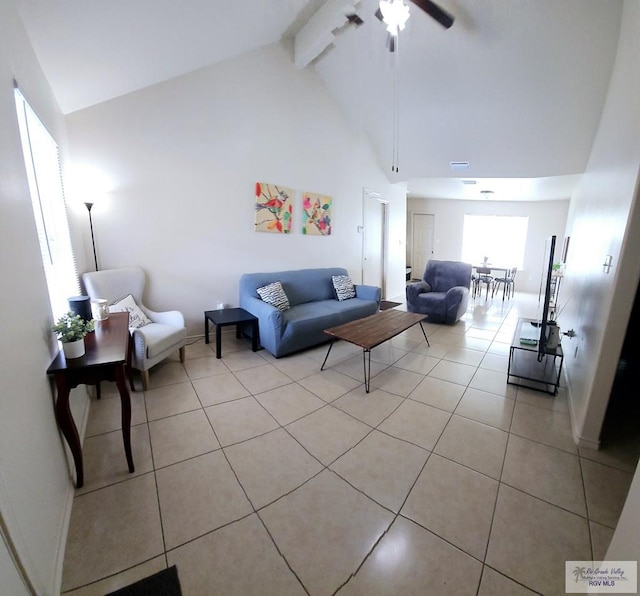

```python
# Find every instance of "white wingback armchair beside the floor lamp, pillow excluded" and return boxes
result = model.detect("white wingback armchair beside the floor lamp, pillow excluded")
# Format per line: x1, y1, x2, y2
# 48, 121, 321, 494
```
82, 267, 187, 391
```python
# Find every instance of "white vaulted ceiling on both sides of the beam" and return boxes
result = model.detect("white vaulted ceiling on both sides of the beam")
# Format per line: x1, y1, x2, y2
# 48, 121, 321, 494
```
14, 0, 624, 200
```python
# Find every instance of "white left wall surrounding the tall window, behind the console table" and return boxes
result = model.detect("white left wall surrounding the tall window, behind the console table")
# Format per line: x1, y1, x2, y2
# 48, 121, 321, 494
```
0, 2, 84, 594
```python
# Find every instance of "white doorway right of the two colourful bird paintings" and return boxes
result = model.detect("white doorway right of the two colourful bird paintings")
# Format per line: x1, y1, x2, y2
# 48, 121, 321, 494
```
362, 188, 389, 299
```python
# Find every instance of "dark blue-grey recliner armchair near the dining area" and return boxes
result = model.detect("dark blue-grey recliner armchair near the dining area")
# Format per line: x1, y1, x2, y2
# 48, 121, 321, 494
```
406, 259, 471, 325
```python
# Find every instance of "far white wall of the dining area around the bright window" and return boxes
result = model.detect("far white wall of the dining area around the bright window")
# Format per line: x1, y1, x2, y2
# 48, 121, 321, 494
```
407, 198, 569, 292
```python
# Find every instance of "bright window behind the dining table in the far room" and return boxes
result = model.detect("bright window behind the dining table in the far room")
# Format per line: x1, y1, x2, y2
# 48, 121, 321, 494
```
462, 214, 529, 269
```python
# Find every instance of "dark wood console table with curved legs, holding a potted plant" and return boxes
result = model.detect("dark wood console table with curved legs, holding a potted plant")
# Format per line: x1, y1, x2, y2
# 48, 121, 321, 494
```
47, 312, 134, 488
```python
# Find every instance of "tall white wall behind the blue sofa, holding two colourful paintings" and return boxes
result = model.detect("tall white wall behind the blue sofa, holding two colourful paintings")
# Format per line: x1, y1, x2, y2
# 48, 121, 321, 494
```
67, 44, 406, 335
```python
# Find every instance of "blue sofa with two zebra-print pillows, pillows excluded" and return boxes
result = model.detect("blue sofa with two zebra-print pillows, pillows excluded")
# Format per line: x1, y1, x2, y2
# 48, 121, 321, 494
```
239, 267, 380, 358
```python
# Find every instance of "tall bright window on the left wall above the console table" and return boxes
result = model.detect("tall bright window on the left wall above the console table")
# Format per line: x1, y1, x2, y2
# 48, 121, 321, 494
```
15, 88, 80, 318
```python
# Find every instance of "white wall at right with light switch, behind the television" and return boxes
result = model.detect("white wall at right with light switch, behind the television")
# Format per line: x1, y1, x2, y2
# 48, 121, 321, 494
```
559, 2, 640, 446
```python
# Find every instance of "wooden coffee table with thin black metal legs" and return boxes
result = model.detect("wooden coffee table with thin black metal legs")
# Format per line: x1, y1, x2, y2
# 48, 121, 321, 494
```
320, 310, 429, 393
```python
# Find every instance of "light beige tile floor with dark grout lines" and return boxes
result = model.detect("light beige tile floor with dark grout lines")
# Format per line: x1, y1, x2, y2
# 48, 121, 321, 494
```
63, 295, 638, 596
